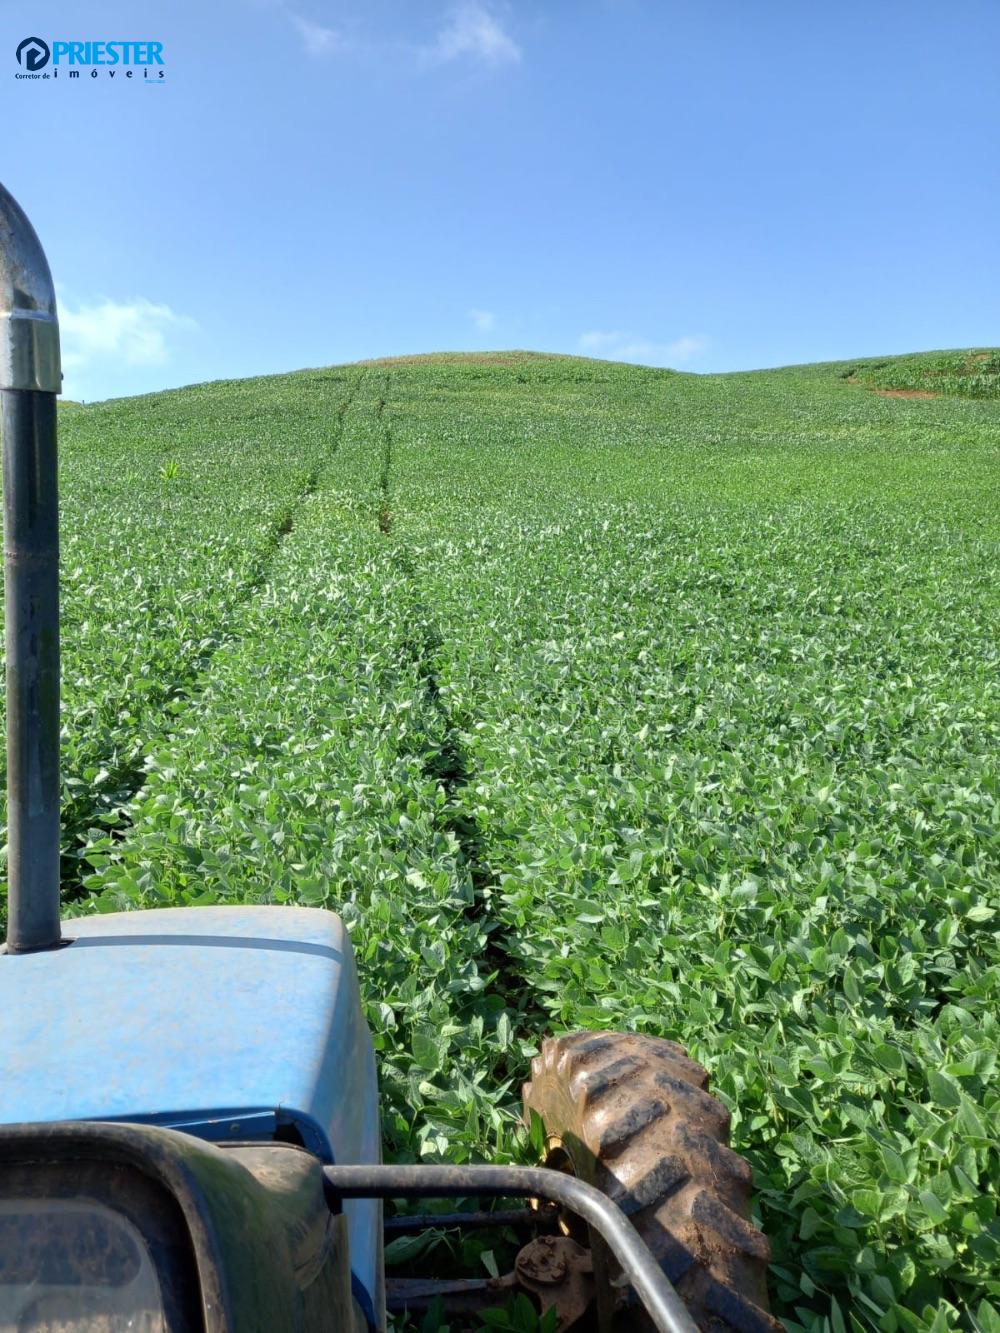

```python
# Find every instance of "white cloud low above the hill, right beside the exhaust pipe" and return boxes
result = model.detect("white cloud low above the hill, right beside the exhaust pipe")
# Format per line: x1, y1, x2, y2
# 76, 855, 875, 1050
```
59, 296, 197, 392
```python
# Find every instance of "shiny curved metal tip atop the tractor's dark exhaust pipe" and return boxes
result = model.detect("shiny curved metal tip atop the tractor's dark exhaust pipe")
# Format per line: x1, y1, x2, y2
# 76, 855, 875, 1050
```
0, 185, 63, 393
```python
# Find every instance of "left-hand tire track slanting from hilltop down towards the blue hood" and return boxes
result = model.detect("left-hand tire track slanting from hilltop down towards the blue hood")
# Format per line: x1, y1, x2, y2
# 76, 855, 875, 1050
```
60, 371, 369, 900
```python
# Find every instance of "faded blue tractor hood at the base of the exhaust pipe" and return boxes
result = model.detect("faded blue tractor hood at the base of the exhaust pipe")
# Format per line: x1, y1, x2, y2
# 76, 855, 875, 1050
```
0, 906, 381, 1317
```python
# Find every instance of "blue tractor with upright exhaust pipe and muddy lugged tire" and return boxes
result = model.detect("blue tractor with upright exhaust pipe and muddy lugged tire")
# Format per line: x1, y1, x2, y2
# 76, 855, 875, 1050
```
0, 179, 780, 1333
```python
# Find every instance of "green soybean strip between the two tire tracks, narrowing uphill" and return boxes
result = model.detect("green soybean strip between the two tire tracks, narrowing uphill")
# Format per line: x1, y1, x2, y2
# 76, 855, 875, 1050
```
75, 375, 528, 1157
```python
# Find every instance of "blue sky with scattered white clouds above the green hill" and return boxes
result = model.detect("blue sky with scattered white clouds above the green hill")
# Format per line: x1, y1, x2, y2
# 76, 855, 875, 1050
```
0, 0, 1000, 401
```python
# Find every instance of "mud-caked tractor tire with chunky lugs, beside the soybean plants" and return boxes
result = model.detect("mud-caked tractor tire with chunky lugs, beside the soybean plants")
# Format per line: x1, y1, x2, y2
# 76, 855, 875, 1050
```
523, 1032, 781, 1333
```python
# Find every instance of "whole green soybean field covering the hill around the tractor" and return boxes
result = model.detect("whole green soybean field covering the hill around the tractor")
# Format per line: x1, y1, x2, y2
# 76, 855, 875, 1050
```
1, 351, 1000, 1333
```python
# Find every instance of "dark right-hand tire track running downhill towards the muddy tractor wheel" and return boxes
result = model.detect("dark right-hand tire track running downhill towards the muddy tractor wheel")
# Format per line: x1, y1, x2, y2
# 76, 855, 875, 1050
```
376, 386, 548, 1039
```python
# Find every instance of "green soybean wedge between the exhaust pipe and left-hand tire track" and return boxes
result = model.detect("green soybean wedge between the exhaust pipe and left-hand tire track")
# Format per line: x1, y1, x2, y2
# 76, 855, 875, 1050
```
0, 372, 365, 911
